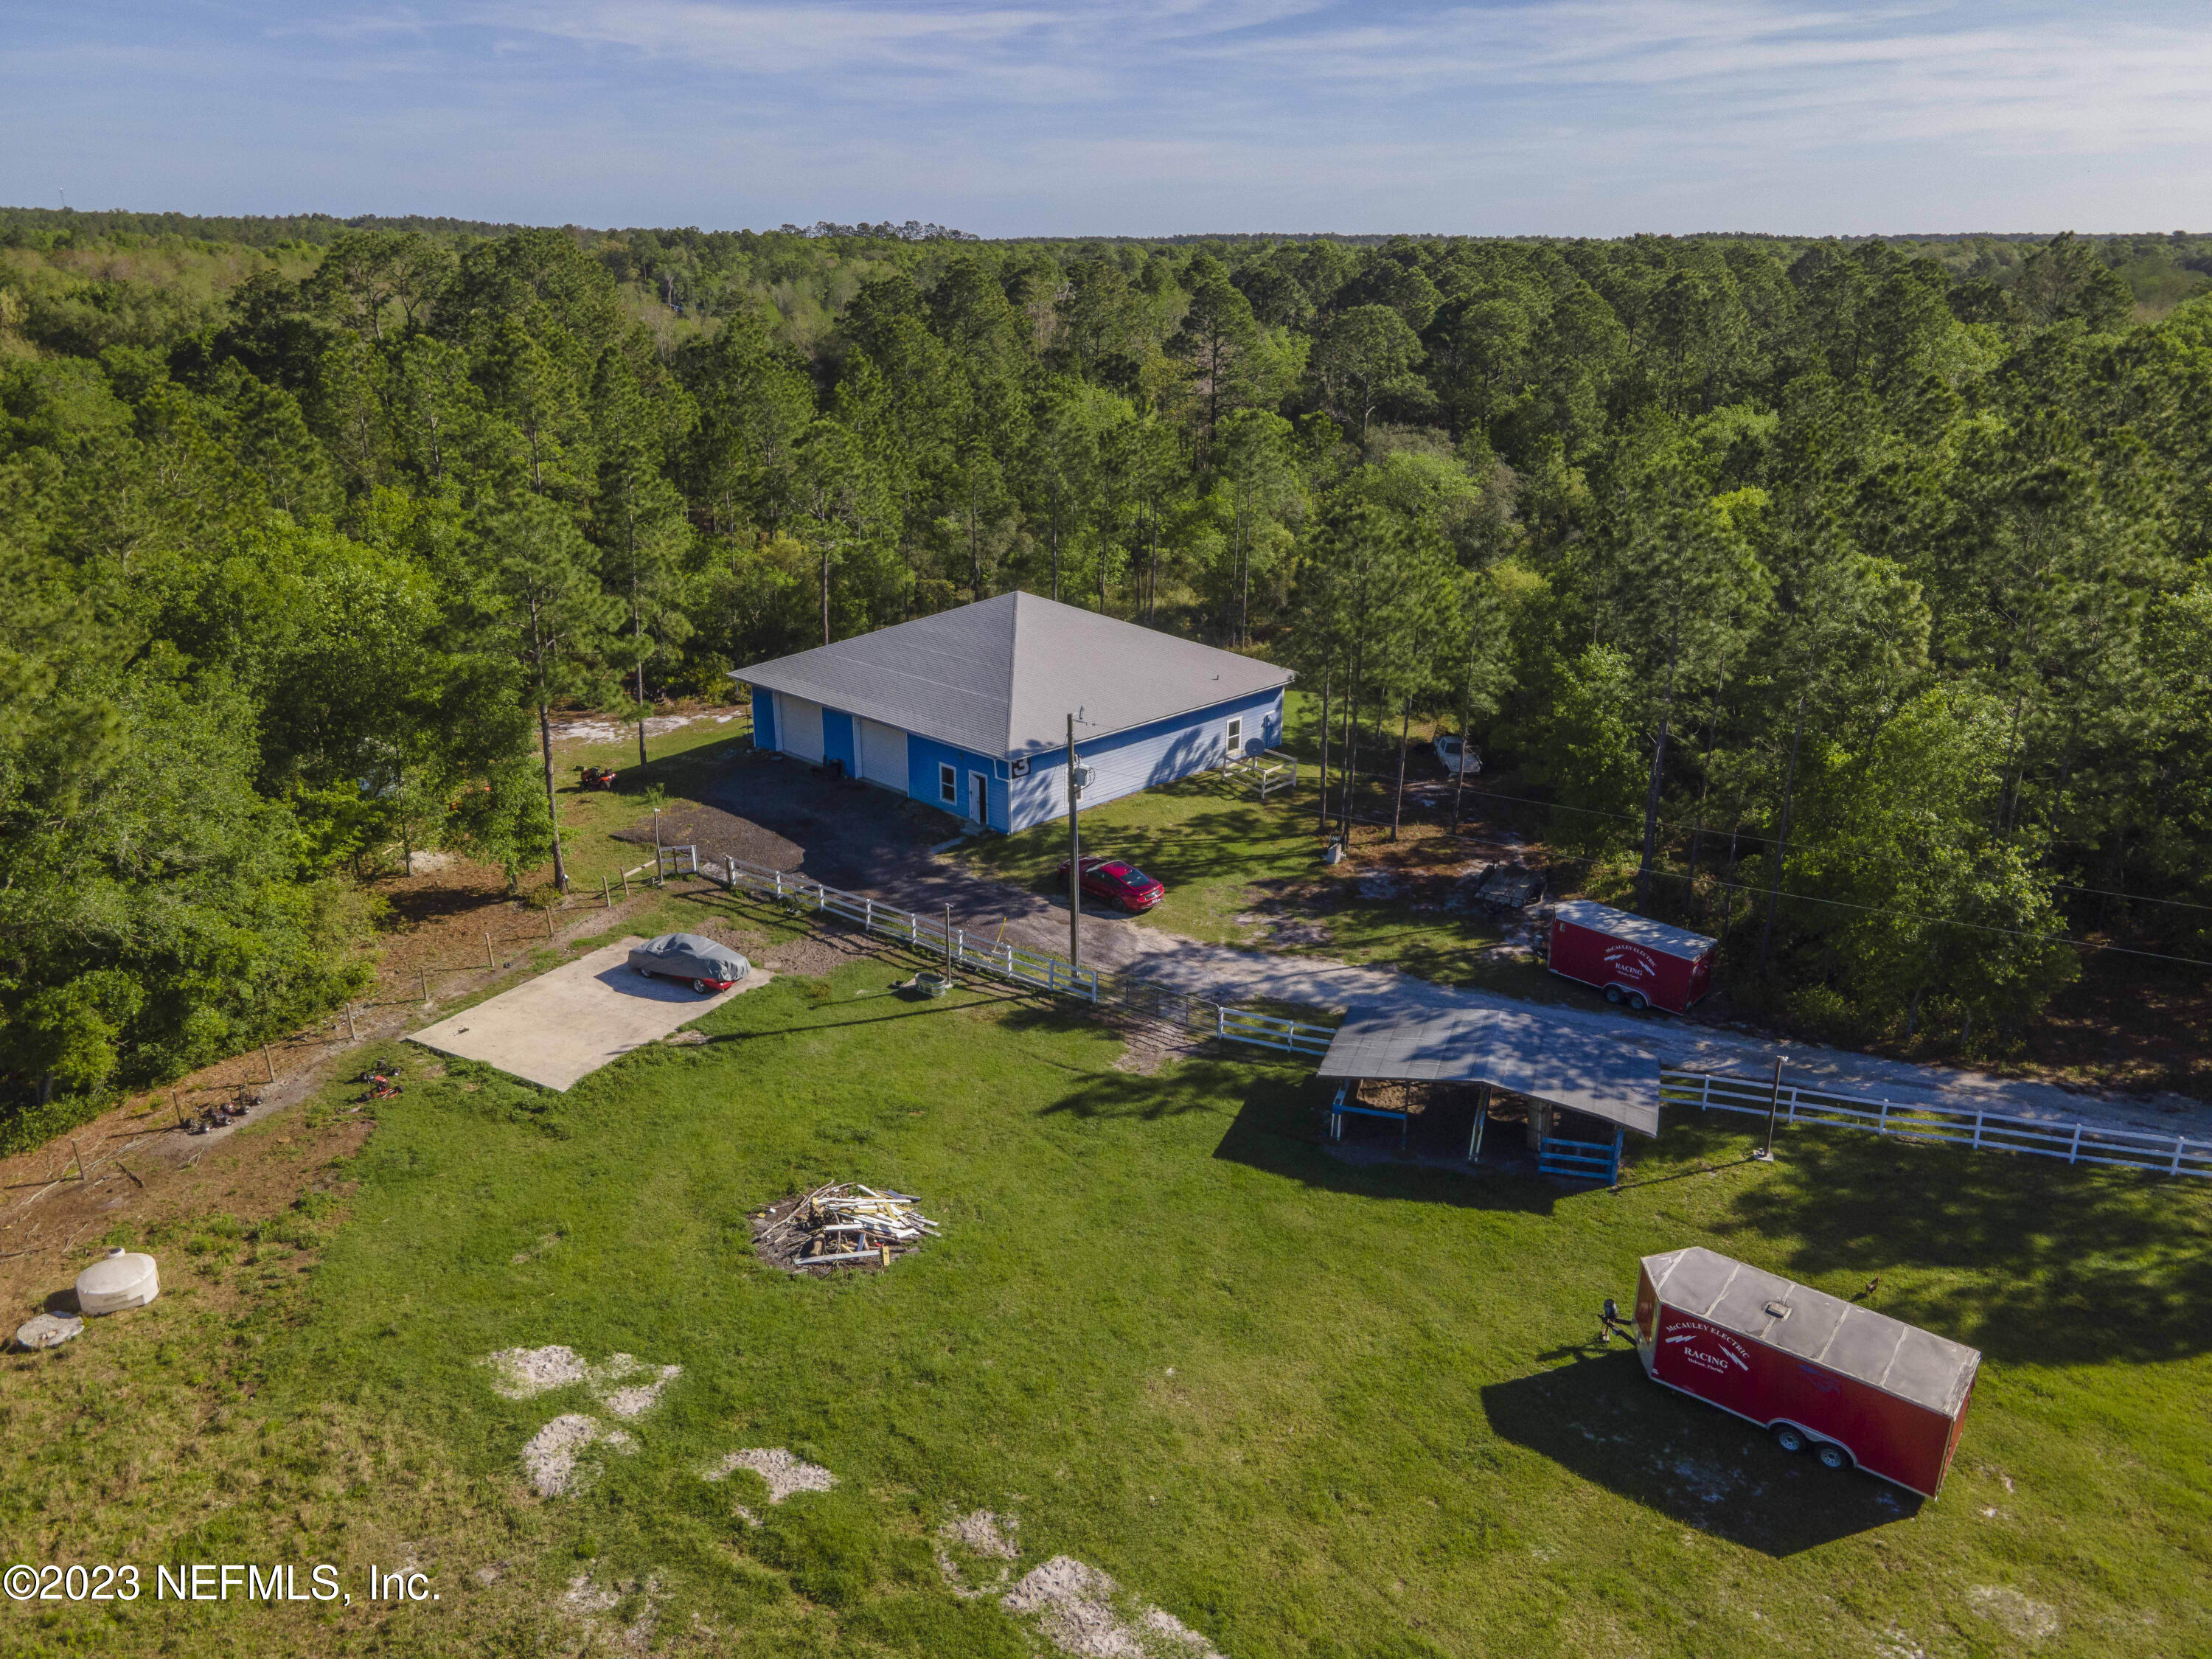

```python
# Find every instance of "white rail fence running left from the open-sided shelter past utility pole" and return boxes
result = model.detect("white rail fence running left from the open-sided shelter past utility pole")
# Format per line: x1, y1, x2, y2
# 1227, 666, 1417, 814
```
701, 858, 1336, 1055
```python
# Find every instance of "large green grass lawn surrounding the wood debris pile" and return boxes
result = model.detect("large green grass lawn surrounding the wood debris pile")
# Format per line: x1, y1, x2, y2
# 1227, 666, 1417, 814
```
0, 898, 2212, 1659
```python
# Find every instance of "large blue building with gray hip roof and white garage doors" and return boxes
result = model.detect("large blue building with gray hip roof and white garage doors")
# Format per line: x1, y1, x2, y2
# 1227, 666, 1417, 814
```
732, 593, 1292, 832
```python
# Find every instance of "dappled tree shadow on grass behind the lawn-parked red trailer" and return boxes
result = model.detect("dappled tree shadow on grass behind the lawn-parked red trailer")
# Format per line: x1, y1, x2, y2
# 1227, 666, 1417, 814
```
1734, 1130, 2212, 1365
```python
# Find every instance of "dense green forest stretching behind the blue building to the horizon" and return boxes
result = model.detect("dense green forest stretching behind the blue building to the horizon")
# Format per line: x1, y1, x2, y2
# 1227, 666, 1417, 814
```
0, 210, 2212, 1141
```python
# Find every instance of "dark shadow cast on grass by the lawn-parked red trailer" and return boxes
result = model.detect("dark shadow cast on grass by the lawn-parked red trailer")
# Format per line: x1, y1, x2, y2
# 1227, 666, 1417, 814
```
1482, 1349, 1920, 1557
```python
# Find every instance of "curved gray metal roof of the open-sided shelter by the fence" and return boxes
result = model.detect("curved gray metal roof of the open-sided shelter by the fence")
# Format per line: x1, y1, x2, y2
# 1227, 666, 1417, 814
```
1321, 1009, 1659, 1135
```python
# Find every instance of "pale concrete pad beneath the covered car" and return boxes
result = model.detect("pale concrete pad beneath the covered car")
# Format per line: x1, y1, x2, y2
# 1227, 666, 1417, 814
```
411, 936, 776, 1091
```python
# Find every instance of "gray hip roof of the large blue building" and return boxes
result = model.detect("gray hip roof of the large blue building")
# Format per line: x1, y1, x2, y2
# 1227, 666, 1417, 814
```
732, 593, 1292, 757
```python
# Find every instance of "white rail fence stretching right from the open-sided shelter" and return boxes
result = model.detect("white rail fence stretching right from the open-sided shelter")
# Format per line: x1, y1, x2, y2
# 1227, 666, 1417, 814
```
1659, 1066, 2212, 1177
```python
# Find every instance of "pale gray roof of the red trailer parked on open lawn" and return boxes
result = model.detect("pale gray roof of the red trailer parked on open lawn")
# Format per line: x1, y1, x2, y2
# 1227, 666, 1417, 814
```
1644, 1245, 1982, 1418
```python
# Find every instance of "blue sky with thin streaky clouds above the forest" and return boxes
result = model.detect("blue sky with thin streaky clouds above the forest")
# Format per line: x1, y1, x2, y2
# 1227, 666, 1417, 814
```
0, 0, 2212, 237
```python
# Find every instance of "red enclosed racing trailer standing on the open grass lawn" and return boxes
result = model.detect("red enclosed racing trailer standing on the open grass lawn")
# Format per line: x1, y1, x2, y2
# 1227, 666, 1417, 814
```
1637, 1245, 1982, 1498
